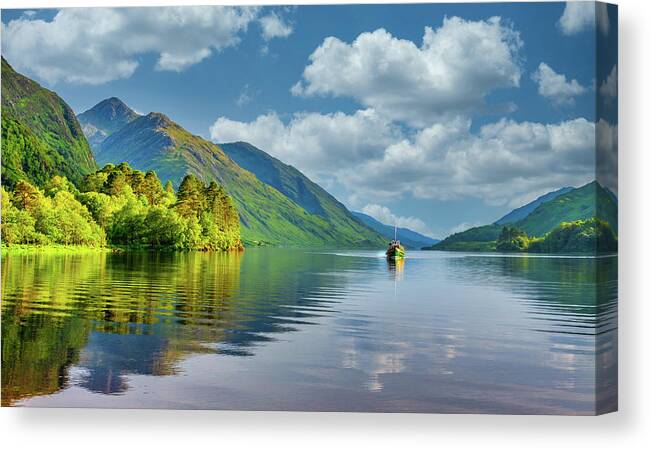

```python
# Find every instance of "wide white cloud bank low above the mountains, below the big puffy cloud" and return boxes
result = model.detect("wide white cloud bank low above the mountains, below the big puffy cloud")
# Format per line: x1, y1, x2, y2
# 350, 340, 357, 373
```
211, 109, 595, 206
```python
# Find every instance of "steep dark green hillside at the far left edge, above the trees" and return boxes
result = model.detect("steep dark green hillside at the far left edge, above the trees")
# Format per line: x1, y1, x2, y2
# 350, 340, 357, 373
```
2, 58, 97, 187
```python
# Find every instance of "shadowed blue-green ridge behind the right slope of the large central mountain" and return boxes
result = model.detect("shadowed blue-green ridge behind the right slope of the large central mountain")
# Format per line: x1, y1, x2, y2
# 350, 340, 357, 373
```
219, 142, 384, 245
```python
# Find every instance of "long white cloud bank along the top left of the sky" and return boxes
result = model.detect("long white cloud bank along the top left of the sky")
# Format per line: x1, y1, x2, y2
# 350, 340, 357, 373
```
2, 6, 291, 84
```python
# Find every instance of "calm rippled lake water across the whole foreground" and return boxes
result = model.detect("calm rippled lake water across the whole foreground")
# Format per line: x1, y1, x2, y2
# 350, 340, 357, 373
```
2, 249, 617, 414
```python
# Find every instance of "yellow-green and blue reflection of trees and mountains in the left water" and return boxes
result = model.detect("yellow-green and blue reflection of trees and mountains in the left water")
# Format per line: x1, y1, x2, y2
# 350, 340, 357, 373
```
2, 251, 352, 405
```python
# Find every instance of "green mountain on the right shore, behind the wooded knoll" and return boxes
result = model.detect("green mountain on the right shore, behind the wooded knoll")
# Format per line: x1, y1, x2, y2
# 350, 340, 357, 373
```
429, 181, 617, 251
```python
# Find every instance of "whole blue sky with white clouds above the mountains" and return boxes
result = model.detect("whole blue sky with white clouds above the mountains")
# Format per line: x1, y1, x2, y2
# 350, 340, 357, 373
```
2, 2, 617, 238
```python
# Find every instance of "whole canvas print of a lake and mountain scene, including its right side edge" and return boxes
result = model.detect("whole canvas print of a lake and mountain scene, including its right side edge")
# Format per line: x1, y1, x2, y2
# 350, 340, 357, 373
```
1, 2, 618, 415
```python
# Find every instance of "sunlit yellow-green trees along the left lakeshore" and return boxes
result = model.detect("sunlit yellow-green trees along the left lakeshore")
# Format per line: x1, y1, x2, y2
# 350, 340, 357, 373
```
2, 163, 243, 251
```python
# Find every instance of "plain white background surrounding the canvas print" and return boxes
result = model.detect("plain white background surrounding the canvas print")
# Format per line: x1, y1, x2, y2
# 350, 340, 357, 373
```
0, 0, 651, 449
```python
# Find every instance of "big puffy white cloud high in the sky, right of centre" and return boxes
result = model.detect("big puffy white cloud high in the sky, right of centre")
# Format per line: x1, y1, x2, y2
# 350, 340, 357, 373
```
292, 17, 522, 126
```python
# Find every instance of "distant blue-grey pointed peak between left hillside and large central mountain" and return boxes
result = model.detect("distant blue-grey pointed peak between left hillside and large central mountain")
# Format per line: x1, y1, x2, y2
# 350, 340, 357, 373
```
77, 97, 140, 149
